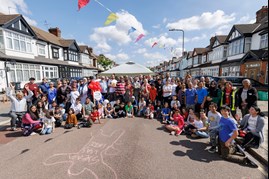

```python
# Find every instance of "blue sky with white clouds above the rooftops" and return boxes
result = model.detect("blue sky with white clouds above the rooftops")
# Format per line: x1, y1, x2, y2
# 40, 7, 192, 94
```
0, 0, 268, 67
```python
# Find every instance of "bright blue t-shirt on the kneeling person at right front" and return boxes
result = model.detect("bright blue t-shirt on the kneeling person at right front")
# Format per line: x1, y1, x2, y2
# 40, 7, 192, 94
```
219, 117, 238, 142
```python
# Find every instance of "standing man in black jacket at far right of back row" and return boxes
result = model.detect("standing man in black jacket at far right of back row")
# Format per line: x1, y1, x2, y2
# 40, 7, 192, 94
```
236, 79, 258, 117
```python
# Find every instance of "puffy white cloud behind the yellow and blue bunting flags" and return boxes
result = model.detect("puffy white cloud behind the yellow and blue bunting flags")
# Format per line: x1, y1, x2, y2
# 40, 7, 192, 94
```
89, 11, 147, 51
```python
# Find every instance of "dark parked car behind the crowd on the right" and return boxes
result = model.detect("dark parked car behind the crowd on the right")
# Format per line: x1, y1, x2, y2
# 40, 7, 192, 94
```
214, 76, 268, 91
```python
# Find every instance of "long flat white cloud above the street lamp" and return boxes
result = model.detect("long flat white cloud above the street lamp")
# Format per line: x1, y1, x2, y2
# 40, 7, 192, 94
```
166, 10, 235, 30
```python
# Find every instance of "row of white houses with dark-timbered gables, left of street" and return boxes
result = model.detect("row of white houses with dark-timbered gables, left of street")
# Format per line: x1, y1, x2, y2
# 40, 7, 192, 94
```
0, 13, 97, 91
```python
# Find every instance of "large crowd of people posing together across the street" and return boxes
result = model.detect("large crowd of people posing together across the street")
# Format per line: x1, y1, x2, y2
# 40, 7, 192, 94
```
7, 73, 264, 166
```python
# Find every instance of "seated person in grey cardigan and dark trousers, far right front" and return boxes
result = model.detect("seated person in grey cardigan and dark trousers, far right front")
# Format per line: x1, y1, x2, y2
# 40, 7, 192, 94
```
236, 105, 265, 149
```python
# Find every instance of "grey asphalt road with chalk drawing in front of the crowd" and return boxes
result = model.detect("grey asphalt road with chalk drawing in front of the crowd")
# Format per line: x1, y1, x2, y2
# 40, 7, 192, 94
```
0, 118, 266, 179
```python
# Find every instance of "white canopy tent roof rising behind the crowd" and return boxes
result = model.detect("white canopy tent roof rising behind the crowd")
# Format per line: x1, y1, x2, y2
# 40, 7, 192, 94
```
99, 61, 154, 76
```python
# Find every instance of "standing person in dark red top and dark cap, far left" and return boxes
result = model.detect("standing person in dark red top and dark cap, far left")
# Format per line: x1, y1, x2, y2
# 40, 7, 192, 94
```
23, 77, 39, 107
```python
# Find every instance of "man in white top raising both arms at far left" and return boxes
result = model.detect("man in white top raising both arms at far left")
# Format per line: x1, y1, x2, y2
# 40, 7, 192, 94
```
7, 85, 34, 131
